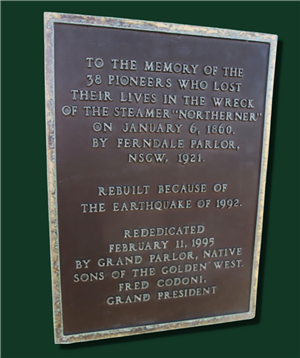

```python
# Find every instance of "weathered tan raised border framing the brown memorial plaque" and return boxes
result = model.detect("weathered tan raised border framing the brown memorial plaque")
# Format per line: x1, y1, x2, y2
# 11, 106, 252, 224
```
44, 12, 278, 344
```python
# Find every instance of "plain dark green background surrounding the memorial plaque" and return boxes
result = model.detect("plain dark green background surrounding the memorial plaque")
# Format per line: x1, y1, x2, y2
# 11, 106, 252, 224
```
1, 1, 300, 358
